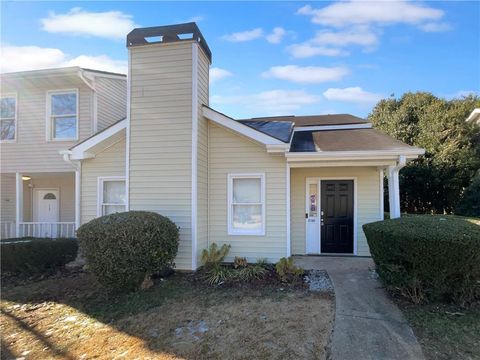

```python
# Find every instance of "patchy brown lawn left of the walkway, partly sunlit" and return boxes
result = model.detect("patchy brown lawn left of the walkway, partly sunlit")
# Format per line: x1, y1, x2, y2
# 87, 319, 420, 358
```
0, 272, 334, 359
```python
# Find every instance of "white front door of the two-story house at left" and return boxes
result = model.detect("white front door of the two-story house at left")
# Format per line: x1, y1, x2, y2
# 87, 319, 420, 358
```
33, 189, 59, 237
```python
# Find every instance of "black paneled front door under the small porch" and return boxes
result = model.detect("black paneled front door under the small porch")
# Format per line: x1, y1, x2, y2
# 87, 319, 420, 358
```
321, 180, 353, 254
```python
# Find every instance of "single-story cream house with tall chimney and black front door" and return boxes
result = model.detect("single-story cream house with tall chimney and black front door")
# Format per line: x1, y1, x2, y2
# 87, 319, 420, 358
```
2, 23, 424, 270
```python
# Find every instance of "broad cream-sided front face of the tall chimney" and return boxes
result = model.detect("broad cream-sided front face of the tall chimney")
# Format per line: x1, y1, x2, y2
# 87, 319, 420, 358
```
129, 41, 192, 269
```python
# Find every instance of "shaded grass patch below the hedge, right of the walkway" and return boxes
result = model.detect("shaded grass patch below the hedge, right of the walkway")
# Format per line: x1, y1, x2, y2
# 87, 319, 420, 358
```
400, 303, 480, 360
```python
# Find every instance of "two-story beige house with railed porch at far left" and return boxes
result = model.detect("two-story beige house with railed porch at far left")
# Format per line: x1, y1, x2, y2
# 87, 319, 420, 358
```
0, 67, 127, 238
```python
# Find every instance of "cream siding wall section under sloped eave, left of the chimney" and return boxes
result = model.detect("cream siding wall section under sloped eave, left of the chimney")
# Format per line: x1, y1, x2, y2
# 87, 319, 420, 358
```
80, 138, 125, 224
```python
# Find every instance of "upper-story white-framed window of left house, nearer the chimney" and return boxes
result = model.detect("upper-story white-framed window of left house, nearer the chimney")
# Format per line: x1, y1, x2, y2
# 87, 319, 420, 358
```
48, 90, 78, 140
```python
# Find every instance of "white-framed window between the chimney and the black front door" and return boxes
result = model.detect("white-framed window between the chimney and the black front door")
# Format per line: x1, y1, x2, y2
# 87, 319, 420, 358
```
228, 174, 265, 235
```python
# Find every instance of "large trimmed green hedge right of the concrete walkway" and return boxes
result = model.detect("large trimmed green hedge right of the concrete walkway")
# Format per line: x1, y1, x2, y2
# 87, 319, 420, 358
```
363, 215, 480, 305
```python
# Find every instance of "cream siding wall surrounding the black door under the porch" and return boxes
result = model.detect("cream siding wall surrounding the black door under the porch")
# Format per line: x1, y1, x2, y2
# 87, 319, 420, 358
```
290, 167, 383, 256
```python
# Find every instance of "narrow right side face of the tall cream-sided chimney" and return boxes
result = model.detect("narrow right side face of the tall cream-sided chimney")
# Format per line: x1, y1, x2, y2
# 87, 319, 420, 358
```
197, 47, 210, 266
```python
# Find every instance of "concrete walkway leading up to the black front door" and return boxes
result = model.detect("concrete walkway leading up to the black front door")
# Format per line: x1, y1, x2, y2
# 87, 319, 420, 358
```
294, 256, 424, 360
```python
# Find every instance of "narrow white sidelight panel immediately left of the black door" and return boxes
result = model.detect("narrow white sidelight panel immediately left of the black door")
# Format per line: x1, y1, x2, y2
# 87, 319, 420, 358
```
305, 179, 320, 254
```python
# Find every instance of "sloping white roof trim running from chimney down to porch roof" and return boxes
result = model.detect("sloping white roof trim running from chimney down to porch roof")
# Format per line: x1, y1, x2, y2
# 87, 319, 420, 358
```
202, 106, 289, 152
